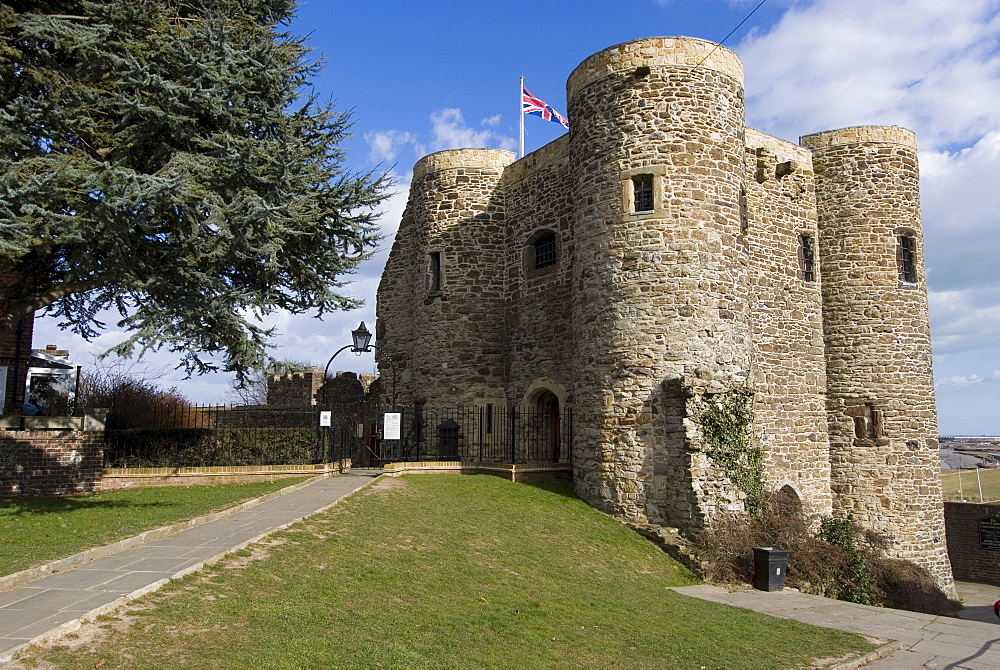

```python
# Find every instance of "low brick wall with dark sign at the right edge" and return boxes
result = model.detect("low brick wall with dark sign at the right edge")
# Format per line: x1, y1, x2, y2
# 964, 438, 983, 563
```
944, 502, 1000, 586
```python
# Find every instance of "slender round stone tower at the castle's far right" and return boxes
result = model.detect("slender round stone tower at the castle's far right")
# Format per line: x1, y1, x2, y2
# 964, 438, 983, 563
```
801, 126, 952, 590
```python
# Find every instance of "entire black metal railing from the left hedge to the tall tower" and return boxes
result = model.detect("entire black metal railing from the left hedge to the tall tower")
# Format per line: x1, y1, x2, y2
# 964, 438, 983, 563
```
94, 402, 573, 468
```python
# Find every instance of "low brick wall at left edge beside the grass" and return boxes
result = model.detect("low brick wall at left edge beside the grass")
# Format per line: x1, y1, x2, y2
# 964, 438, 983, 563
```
0, 430, 104, 497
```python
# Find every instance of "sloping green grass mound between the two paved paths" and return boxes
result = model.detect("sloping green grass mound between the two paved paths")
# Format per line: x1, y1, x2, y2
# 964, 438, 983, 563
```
22, 475, 872, 670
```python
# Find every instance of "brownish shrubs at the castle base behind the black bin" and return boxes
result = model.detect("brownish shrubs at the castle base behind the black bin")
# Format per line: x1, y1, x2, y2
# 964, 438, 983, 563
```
696, 495, 962, 615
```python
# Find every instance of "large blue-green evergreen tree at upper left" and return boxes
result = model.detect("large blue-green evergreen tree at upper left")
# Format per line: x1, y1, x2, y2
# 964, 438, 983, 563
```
0, 0, 387, 374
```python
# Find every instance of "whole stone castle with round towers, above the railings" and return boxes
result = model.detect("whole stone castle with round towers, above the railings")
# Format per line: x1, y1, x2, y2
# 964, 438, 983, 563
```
377, 37, 952, 590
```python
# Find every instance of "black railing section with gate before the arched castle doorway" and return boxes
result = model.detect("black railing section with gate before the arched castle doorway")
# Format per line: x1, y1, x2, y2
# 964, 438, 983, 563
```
326, 403, 573, 467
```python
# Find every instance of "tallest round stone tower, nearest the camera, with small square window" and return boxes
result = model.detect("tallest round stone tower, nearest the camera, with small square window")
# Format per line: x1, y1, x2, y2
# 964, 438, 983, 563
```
567, 37, 751, 527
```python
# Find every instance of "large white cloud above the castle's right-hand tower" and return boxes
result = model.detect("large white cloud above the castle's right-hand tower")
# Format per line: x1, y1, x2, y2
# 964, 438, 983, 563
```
737, 0, 1000, 147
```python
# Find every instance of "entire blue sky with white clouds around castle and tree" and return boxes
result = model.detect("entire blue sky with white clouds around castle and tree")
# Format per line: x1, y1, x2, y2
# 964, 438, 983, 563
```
35, 0, 1000, 435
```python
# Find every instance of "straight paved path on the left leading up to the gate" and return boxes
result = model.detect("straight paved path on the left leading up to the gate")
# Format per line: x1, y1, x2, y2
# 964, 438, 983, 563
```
0, 471, 376, 663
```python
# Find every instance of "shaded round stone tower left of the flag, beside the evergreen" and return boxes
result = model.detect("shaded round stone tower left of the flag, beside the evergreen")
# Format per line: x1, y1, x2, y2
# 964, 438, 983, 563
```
379, 149, 514, 407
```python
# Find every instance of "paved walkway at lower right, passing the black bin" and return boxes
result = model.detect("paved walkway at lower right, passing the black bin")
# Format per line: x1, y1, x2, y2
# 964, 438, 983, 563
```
674, 582, 1000, 670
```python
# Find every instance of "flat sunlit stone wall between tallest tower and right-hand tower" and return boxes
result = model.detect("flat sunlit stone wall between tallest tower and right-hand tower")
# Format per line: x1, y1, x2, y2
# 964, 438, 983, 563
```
739, 128, 832, 515
